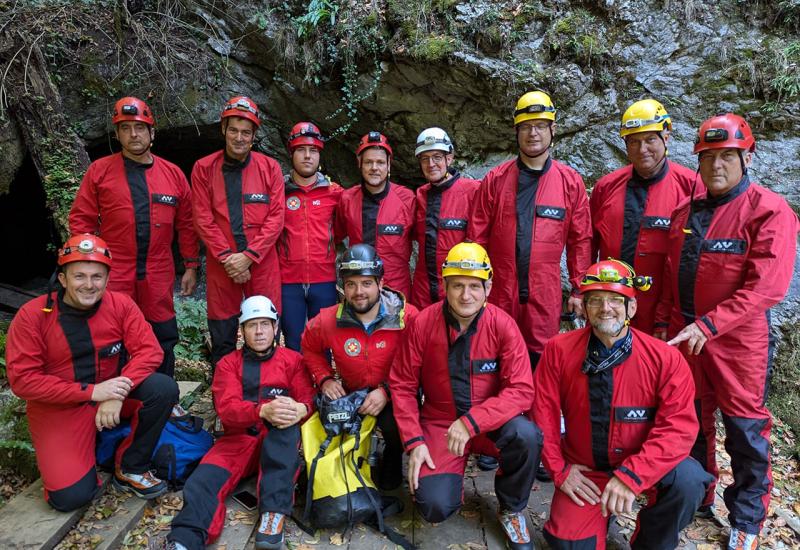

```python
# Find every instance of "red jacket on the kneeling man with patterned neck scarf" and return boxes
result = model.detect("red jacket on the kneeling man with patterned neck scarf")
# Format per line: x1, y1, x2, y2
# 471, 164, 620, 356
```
533, 327, 698, 494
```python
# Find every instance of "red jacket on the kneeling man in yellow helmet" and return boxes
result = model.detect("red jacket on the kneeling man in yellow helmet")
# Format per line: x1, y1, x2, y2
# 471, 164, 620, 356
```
389, 301, 534, 451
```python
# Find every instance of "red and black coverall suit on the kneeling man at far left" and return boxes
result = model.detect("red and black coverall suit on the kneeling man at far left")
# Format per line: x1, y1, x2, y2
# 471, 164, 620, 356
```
6, 290, 178, 511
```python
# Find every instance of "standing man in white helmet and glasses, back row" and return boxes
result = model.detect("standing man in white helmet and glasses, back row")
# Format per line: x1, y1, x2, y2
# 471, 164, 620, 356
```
411, 128, 479, 308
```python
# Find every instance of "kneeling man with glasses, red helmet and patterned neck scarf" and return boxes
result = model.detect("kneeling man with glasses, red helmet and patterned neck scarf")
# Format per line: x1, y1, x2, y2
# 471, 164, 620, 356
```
533, 260, 712, 550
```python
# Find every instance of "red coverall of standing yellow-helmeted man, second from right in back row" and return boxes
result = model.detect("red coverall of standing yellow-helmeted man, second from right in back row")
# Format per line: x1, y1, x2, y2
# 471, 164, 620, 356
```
589, 161, 697, 334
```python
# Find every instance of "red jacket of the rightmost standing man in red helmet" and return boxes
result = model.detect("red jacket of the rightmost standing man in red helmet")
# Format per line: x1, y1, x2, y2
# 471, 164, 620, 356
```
656, 177, 800, 380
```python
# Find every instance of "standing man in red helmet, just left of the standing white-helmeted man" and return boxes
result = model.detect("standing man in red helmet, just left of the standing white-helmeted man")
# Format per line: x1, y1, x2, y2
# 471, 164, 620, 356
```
336, 132, 414, 297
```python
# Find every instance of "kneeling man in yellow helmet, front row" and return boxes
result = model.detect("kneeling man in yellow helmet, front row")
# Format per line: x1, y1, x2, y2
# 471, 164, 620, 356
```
389, 243, 540, 550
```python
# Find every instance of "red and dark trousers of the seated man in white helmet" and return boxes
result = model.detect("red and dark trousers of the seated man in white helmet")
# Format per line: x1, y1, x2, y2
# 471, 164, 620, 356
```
168, 424, 300, 550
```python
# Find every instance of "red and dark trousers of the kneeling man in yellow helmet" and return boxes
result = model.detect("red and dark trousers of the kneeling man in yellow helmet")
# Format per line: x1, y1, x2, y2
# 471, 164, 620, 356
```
414, 416, 542, 523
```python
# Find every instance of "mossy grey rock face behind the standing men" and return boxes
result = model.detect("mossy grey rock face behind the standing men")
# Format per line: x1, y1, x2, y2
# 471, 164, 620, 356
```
0, 0, 800, 322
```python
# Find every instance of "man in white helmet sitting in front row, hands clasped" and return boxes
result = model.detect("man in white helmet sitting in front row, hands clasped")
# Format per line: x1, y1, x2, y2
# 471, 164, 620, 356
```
167, 296, 314, 550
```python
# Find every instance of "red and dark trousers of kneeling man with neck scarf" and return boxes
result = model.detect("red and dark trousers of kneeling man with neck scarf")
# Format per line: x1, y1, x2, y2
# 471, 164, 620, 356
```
544, 458, 712, 550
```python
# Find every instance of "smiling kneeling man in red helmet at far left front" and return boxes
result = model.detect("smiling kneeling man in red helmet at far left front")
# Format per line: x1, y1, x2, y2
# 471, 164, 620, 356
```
6, 234, 178, 512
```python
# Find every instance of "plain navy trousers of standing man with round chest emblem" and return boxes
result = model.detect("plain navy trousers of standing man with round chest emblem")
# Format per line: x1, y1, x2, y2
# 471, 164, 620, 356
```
281, 281, 339, 351
